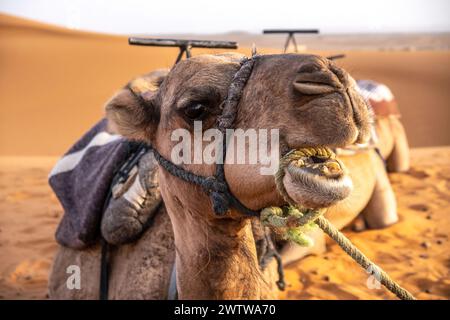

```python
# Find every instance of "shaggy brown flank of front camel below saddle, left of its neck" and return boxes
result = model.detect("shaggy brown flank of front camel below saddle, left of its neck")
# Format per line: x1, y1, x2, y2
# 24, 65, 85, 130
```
49, 207, 175, 299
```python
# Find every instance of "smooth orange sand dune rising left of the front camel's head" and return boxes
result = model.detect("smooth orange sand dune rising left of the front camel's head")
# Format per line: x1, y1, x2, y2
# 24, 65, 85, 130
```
0, 15, 260, 155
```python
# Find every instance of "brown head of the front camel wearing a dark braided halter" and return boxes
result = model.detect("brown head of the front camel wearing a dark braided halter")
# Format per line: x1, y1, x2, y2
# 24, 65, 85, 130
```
106, 54, 371, 216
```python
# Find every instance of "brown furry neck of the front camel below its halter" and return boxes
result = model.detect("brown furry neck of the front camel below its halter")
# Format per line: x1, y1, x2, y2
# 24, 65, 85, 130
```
161, 174, 264, 299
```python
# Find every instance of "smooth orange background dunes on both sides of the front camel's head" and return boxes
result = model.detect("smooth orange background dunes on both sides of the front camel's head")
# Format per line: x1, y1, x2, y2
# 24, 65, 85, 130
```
0, 15, 450, 155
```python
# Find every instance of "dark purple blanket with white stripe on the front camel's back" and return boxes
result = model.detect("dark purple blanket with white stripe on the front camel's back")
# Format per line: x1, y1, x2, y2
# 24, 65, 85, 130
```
49, 119, 138, 249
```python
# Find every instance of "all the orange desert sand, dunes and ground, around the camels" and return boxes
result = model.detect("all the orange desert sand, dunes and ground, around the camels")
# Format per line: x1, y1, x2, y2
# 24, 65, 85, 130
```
0, 15, 450, 299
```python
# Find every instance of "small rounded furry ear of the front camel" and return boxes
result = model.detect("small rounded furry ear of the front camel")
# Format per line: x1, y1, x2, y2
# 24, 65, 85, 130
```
105, 70, 168, 142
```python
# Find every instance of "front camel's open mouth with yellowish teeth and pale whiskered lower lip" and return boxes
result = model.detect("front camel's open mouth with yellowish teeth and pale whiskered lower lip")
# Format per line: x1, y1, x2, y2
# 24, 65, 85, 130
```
283, 147, 353, 208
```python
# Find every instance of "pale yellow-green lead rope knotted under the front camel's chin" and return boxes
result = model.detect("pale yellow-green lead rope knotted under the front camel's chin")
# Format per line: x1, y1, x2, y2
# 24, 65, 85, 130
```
261, 148, 415, 300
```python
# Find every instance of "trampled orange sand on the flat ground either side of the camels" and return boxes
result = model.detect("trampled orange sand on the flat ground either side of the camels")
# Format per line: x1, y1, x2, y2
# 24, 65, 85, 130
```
0, 147, 450, 299
